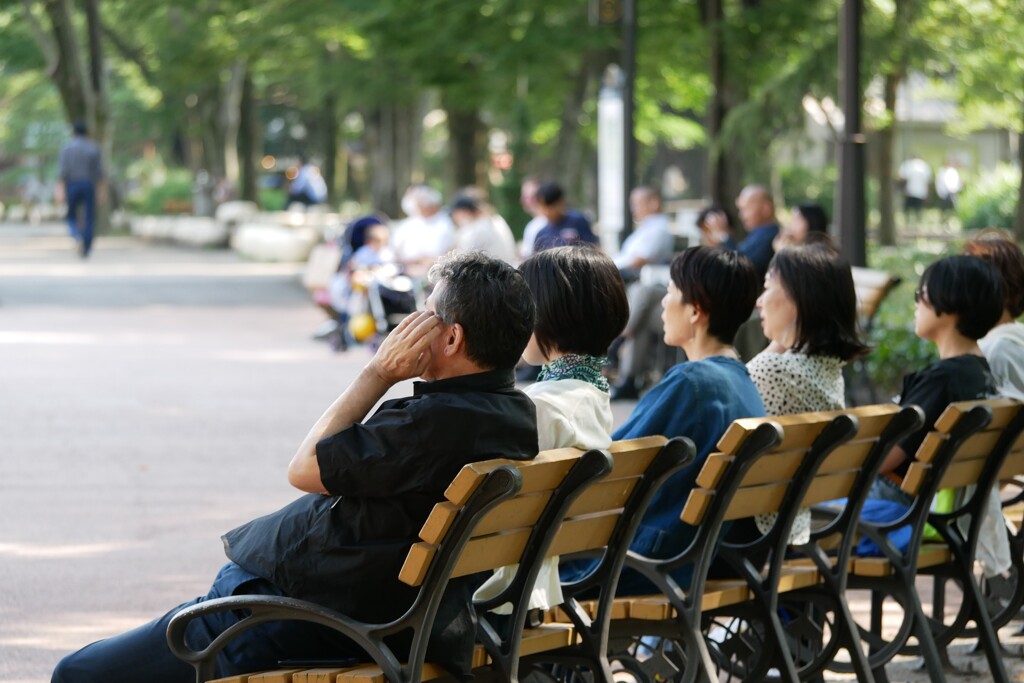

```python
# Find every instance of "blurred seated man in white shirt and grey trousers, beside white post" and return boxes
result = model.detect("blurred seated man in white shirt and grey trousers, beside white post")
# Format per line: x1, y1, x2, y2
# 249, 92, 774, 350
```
611, 186, 673, 400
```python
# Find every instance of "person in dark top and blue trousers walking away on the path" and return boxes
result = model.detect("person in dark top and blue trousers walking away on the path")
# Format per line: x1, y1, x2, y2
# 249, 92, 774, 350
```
60, 121, 103, 258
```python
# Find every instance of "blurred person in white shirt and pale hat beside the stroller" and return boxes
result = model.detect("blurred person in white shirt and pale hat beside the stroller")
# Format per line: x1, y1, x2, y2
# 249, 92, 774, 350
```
391, 185, 455, 278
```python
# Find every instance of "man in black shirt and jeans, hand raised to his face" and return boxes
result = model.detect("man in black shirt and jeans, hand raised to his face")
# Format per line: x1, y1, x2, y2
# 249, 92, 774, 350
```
52, 253, 538, 683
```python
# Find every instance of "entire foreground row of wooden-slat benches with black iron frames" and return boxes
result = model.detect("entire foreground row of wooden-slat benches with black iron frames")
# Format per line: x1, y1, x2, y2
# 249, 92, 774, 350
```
168, 399, 1024, 683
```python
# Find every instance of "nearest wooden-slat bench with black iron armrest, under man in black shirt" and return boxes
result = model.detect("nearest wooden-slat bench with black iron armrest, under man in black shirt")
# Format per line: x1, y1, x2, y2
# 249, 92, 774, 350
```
168, 437, 693, 683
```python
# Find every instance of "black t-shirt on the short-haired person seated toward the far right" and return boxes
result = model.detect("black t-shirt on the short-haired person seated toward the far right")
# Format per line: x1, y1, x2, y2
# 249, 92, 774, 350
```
893, 355, 995, 477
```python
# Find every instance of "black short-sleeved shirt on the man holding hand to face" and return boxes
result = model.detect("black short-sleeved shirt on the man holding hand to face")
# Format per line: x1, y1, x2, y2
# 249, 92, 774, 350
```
223, 370, 538, 671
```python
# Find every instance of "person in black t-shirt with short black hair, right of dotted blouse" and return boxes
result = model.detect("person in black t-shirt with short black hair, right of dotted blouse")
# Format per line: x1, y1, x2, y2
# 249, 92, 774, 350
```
869, 256, 1004, 505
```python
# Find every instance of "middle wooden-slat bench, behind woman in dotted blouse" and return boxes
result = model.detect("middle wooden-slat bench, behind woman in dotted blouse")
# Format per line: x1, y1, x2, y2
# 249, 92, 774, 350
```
538, 404, 922, 681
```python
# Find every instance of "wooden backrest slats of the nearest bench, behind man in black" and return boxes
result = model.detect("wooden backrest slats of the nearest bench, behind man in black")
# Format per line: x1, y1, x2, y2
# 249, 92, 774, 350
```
399, 436, 667, 586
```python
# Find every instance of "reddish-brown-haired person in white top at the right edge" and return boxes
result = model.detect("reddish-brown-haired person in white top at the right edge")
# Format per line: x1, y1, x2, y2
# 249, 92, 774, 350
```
964, 229, 1024, 400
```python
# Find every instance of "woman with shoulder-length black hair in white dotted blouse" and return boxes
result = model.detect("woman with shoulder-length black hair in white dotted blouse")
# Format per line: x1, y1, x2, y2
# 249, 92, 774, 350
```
746, 242, 868, 544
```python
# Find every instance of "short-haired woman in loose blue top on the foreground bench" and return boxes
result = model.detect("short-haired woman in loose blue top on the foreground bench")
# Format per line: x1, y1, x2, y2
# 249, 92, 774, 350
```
585, 247, 764, 595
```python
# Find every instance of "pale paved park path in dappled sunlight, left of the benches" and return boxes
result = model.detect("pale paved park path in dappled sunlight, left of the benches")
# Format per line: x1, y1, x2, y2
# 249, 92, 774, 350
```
0, 223, 1024, 683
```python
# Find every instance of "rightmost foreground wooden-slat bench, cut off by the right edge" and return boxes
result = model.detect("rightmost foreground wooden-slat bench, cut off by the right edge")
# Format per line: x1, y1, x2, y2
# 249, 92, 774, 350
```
835, 398, 1024, 682
